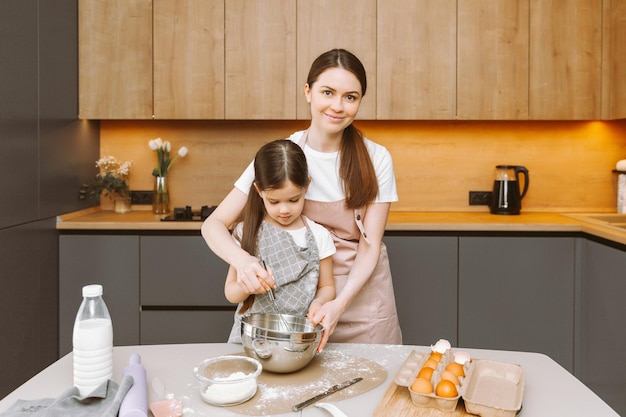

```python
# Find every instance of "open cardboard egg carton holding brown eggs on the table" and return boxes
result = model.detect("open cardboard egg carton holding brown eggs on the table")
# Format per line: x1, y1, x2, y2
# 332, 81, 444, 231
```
394, 350, 525, 417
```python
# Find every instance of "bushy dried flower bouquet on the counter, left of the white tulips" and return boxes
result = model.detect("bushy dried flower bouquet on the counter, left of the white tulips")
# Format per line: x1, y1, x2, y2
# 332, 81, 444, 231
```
79, 156, 132, 203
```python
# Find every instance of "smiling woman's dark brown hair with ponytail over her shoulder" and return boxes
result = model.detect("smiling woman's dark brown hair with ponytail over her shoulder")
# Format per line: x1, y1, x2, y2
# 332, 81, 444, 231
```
306, 49, 378, 208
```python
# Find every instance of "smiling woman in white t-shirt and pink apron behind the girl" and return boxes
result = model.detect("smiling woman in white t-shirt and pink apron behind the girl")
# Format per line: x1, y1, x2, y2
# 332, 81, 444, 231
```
202, 49, 402, 344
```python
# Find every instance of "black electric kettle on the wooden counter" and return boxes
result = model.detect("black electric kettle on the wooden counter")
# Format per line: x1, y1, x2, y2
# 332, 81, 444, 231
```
489, 165, 530, 214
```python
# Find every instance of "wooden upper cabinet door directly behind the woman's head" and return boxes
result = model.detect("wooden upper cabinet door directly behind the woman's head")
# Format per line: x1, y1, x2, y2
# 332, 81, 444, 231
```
291, 0, 377, 119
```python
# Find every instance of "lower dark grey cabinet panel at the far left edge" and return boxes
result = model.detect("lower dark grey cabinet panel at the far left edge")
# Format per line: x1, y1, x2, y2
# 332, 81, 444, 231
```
0, 219, 59, 398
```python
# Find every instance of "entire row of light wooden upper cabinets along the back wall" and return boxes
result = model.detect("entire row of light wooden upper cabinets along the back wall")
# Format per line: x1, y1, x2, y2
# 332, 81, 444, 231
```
78, 0, 626, 120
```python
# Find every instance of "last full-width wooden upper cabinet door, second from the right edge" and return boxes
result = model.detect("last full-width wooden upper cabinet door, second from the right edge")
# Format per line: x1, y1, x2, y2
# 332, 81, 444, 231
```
530, 0, 604, 120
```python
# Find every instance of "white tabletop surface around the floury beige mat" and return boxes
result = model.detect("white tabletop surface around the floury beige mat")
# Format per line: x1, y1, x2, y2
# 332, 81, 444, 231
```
0, 343, 619, 417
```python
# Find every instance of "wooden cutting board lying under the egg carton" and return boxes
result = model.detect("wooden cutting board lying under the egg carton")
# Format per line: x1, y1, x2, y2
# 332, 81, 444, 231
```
374, 381, 476, 417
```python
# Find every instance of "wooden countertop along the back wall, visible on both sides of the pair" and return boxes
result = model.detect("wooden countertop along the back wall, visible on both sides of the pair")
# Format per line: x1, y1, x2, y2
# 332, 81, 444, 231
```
52, 206, 626, 244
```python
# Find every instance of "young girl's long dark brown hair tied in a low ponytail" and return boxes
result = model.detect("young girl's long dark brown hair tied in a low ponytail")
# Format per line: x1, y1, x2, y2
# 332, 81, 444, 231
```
239, 139, 309, 254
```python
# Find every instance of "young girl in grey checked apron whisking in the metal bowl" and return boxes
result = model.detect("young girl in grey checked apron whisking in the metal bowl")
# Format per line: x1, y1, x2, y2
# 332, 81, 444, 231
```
224, 140, 335, 346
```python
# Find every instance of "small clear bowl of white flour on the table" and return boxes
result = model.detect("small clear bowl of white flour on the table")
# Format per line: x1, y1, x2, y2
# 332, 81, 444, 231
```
193, 355, 263, 407
